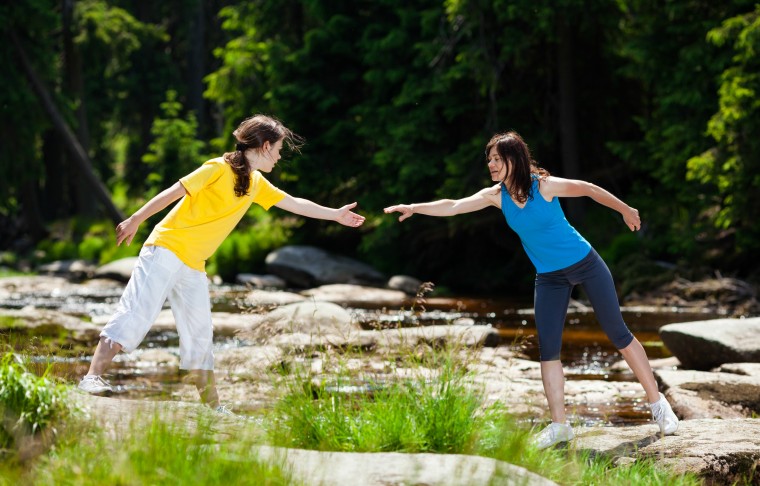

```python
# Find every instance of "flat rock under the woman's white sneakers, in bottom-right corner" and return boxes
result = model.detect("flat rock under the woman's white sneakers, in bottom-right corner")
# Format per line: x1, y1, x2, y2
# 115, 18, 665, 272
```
572, 419, 760, 485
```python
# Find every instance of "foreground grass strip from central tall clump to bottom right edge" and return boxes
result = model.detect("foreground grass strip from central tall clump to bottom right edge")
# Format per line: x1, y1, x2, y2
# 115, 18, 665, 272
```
265, 346, 701, 486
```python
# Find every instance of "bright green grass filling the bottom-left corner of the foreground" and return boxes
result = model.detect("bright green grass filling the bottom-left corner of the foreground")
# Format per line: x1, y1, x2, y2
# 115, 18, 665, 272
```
0, 353, 299, 486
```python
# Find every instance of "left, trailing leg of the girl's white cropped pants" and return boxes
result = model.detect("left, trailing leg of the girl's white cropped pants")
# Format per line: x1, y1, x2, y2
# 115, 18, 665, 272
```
100, 246, 184, 353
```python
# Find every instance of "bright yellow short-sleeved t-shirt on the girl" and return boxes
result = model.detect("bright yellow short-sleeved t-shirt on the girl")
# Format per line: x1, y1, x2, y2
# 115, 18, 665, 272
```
145, 157, 285, 272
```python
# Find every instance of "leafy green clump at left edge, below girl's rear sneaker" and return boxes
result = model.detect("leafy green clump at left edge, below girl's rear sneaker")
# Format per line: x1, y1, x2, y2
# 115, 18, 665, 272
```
0, 353, 68, 450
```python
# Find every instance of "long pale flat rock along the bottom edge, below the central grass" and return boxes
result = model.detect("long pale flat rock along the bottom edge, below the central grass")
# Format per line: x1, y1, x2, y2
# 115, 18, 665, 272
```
256, 446, 556, 486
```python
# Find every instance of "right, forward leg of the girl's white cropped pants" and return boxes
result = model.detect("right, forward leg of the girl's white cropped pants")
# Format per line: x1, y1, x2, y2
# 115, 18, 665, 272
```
168, 265, 214, 370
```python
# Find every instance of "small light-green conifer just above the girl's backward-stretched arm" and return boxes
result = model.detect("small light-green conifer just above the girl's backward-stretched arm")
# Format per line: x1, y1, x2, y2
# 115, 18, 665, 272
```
142, 90, 204, 197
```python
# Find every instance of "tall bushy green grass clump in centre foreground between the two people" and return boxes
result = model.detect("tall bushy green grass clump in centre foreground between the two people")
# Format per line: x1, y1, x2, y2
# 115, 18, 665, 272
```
272, 353, 480, 453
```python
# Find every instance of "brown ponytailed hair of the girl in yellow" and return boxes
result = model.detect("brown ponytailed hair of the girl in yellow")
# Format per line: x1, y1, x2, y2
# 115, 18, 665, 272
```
224, 115, 304, 197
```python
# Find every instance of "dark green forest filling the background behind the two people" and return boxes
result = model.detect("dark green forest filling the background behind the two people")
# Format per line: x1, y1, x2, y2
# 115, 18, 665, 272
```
0, 0, 760, 295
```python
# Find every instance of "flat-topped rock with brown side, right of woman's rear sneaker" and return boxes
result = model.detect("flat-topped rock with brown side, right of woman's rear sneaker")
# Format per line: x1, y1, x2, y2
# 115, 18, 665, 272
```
655, 370, 760, 419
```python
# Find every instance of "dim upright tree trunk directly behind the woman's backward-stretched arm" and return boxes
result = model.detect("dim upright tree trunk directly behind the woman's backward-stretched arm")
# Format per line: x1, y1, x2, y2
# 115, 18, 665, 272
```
557, 18, 583, 221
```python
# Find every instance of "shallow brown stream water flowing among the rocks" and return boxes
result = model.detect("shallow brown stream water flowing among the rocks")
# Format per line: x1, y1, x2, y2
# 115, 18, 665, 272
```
0, 280, 718, 425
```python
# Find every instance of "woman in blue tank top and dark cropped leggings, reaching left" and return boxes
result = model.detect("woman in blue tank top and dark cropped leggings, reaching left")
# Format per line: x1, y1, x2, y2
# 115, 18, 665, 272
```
385, 132, 678, 449
